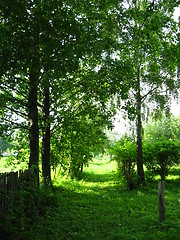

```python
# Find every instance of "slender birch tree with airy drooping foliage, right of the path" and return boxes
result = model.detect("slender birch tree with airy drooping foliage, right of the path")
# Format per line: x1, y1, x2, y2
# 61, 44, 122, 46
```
103, 0, 177, 183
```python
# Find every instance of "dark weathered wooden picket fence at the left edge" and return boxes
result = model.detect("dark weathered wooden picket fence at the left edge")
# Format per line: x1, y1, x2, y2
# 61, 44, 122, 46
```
0, 170, 32, 213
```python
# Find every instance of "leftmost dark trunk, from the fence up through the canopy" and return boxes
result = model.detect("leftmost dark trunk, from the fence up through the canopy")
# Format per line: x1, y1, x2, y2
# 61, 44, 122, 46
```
28, 6, 40, 184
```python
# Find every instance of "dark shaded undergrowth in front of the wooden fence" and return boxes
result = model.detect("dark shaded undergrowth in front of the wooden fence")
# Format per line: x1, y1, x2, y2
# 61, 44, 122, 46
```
0, 184, 58, 240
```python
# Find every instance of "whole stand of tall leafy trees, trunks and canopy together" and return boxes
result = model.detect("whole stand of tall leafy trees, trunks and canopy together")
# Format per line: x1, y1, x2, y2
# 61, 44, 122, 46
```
0, 0, 180, 185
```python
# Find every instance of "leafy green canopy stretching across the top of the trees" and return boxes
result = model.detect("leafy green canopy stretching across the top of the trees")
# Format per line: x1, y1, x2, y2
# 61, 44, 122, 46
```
0, 0, 178, 186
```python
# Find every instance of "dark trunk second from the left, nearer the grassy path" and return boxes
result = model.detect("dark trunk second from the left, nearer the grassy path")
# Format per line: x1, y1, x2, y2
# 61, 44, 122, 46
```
42, 86, 51, 186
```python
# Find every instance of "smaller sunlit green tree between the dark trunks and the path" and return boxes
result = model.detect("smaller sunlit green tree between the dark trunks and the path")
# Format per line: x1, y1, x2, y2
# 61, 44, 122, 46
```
52, 91, 111, 178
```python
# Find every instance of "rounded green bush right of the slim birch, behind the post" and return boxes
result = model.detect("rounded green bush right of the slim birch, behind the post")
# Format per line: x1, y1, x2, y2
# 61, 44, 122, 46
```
143, 116, 180, 179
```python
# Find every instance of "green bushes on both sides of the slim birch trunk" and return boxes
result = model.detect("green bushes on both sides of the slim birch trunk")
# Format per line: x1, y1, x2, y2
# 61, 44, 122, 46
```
111, 116, 180, 183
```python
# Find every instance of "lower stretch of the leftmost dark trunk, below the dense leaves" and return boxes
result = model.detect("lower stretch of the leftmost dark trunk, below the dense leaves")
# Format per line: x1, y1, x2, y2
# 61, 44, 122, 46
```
28, 74, 39, 184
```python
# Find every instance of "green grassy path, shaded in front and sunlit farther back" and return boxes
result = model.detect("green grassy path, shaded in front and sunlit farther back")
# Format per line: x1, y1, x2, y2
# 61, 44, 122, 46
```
33, 159, 180, 240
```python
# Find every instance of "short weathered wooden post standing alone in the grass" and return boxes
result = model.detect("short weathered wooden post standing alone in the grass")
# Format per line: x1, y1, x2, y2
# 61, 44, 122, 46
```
158, 180, 165, 222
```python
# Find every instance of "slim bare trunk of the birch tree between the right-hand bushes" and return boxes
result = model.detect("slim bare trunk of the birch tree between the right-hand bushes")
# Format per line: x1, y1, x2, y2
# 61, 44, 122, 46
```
136, 66, 145, 184
